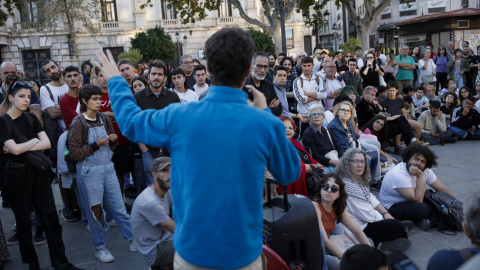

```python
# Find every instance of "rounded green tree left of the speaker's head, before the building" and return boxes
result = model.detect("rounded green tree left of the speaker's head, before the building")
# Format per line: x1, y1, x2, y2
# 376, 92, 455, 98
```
131, 25, 175, 63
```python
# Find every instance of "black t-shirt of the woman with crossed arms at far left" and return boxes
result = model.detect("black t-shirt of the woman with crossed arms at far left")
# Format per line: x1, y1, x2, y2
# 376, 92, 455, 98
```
0, 113, 43, 161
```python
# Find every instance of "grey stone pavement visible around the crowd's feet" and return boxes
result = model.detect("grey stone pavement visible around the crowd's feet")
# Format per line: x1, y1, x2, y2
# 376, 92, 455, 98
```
0, 141, 480, 270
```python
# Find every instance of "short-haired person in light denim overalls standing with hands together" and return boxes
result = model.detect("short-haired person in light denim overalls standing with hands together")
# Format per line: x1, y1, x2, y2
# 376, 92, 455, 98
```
67, 84, 137, 263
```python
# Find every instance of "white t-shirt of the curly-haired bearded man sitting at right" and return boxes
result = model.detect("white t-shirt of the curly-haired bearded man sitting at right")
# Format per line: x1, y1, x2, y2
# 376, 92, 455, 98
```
378, 162, 437, 209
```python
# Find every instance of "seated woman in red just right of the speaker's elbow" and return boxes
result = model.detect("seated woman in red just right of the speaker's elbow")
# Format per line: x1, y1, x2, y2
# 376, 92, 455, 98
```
277, 115, 323, 197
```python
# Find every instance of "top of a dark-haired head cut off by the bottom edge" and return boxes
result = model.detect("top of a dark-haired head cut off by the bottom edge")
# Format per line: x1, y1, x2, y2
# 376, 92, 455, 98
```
340, 244, 387, 270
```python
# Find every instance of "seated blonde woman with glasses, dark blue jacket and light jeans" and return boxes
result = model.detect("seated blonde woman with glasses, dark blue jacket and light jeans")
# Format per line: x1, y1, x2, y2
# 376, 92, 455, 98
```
328, 101, 381, 184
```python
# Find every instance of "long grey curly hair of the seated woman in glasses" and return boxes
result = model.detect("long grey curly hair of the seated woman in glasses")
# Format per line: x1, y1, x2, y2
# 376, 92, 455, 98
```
334, 148, 371, 186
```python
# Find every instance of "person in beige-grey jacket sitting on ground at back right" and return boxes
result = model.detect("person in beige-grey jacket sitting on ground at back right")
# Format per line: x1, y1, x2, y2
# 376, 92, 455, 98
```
417, 100, 457, 145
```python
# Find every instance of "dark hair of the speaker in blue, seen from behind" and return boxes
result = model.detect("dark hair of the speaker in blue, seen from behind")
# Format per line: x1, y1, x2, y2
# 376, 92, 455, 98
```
205, 28, 253, 87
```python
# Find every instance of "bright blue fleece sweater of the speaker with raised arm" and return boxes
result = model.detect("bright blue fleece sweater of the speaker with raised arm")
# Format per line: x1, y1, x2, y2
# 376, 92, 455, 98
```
108, 76, 300, 269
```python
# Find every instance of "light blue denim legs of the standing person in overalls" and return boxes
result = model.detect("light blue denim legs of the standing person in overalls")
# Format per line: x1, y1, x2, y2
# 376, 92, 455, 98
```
77, 162, 133, 249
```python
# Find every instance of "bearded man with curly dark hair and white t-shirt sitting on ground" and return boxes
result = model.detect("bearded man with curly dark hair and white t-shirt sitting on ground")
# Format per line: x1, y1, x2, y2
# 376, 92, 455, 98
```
378, 144, 453, 231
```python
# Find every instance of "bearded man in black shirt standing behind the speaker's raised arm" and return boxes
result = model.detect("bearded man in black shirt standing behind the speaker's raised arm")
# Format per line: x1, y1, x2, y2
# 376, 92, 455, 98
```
133, 60, 180, 192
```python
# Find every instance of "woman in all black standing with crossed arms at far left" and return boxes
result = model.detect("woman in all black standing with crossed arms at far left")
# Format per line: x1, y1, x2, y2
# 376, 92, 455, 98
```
0, 77, 78, 270
